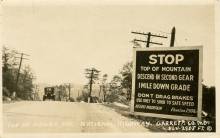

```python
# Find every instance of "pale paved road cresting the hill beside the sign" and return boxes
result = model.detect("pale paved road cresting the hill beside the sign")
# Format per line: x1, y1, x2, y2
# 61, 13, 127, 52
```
3, 101, 149, 133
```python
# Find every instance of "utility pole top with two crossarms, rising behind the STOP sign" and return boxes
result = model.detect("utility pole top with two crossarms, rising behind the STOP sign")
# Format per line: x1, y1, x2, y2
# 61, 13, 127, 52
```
131, 31, 167, 47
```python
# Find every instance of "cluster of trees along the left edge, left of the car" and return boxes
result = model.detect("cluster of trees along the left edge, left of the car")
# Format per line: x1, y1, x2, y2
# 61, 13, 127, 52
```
2, 46, 34, 100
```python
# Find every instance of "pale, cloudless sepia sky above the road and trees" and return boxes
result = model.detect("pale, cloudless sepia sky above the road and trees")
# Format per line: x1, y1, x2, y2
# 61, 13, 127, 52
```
2, 2, 215, 85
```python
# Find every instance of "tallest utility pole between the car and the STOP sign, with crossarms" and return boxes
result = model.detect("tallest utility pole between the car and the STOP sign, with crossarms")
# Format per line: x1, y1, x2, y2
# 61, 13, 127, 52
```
86, 68, 100, 103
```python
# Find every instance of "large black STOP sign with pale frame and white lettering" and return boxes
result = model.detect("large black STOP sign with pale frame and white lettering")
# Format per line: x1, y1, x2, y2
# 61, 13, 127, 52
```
131, 46, 203, 120
